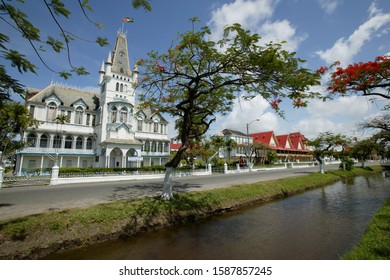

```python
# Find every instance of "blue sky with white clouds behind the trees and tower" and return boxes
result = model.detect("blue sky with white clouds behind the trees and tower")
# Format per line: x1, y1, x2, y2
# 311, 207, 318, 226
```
0, 0, 390, 138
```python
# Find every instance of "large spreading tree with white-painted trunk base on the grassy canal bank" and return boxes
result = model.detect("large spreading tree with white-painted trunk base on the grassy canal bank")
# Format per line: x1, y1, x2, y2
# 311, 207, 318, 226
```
138, 18, 319, 199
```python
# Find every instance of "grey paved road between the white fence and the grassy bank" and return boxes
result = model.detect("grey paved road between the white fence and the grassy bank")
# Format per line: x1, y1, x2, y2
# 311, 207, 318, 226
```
0, 165, 337, 220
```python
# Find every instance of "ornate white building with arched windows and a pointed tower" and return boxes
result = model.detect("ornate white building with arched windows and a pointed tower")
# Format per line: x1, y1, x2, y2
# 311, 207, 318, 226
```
15, 32, 169, 174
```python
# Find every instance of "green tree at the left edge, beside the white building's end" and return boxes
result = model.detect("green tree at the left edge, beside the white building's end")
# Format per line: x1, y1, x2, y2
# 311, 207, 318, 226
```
0, 101, 38, 162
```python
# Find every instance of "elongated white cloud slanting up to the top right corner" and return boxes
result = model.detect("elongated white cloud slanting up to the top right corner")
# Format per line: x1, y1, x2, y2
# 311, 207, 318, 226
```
316, 4, 390, 66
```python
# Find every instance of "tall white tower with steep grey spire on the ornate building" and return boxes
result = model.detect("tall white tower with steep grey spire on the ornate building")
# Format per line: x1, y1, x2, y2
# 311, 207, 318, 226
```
97, 32, 142, 167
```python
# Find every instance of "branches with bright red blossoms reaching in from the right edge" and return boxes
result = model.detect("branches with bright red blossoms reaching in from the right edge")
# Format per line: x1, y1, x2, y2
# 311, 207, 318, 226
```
317, 56, 390, 99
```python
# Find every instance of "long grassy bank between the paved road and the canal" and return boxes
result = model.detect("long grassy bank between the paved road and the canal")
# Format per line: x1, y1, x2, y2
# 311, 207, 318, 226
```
0, 167, 380, 259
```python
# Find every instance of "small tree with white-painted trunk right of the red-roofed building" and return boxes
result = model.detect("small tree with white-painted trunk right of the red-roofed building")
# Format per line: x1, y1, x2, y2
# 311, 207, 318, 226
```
308, 131, 347, 173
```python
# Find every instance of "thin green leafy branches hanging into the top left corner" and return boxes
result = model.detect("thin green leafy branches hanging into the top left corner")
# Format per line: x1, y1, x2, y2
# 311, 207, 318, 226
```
0, 0, 151, 102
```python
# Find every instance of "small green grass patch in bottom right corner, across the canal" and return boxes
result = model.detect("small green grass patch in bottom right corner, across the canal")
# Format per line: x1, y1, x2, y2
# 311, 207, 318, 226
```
342, 195, 390, 260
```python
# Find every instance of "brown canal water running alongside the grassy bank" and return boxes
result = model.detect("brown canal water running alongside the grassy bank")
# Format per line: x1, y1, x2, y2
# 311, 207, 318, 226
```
50, 175, 390, 260
